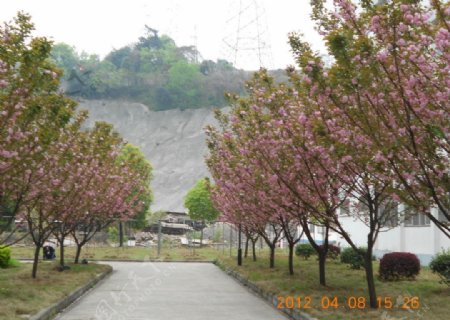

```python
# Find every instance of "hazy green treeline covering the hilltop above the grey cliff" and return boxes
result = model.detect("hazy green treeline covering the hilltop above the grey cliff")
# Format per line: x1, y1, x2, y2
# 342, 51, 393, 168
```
52, 26, 250, 110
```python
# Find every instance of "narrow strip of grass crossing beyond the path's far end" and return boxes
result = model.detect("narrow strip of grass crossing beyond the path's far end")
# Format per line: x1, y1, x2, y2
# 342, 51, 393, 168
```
11, 246, 225, 261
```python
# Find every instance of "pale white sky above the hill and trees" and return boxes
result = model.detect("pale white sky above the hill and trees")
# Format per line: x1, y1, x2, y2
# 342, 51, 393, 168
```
0, 0, 323, 69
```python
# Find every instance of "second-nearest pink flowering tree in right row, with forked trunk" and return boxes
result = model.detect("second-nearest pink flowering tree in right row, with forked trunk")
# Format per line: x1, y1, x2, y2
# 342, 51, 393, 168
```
220, 71, 350, 285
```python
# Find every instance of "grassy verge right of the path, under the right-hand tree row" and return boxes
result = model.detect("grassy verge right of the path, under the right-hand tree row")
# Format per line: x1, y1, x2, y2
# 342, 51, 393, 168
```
220, 253, 450, 320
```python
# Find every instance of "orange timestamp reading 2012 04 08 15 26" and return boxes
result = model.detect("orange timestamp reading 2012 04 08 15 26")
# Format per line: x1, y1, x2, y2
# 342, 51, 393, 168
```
277, 296, 420, 309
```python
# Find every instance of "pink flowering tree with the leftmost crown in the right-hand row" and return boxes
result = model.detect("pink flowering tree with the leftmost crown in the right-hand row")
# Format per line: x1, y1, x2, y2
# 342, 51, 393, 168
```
207, 115, 283, 268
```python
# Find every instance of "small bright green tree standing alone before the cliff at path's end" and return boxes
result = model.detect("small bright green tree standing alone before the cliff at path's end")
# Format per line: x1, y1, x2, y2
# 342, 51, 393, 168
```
184, 178, 219, 246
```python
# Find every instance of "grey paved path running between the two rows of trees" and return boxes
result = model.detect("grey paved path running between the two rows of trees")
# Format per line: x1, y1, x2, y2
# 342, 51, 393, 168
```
56, 262, 287, 320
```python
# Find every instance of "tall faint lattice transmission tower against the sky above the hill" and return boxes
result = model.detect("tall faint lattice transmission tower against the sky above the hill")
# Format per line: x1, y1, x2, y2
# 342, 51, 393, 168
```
222, 0, 273, 70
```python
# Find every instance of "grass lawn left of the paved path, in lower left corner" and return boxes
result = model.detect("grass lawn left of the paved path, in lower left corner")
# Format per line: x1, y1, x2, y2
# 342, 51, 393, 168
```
0, 262, 111, 320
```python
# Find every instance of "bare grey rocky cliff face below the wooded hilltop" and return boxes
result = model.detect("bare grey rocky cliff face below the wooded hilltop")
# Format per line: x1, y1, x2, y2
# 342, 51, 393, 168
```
80, 100, 222, 211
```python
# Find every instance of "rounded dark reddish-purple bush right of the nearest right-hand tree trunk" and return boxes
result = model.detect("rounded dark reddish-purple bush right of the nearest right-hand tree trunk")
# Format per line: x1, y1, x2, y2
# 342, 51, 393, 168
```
379, 252, 420, 281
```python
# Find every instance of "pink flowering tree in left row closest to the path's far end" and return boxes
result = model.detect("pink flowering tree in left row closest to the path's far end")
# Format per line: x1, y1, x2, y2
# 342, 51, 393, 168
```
70, 123, 151, 263
